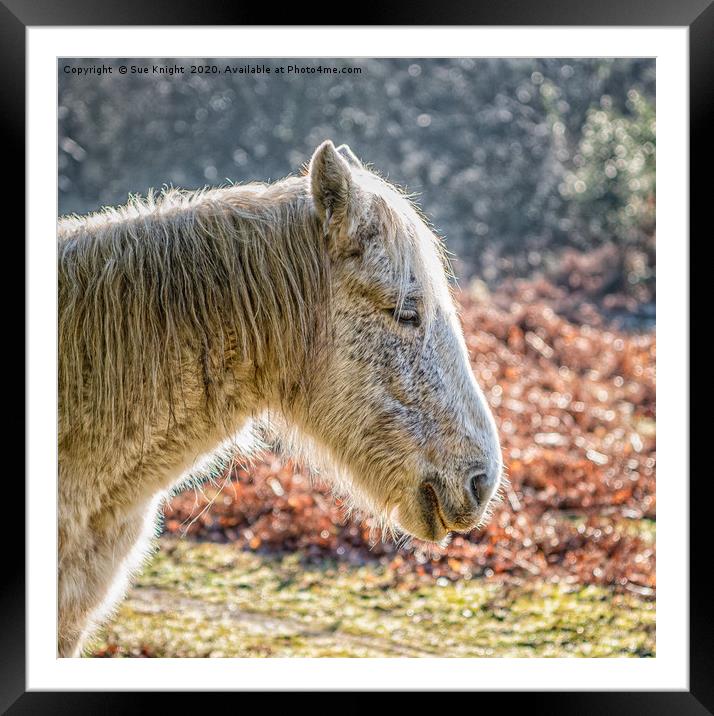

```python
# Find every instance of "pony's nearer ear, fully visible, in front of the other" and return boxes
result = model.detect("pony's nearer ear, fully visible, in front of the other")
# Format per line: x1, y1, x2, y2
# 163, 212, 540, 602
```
308, 139, 355, 228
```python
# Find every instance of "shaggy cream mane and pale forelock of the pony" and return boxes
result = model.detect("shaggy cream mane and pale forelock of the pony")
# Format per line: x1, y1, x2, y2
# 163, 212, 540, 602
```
58, 170, 448, 448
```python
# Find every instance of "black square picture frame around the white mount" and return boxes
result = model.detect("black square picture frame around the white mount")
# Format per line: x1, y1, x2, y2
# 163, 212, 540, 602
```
6, 0, 714, 716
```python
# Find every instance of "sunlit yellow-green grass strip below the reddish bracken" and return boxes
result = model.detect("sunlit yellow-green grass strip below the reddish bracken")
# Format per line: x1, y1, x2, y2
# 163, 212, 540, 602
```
88, 538, 655, 657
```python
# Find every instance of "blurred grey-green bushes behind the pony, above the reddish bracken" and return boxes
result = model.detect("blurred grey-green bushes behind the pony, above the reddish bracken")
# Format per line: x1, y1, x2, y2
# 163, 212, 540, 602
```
59, 58, 655, 305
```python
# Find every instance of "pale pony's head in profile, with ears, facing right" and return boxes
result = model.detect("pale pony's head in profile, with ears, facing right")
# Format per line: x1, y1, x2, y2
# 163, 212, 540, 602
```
286, 141, 503, 542
